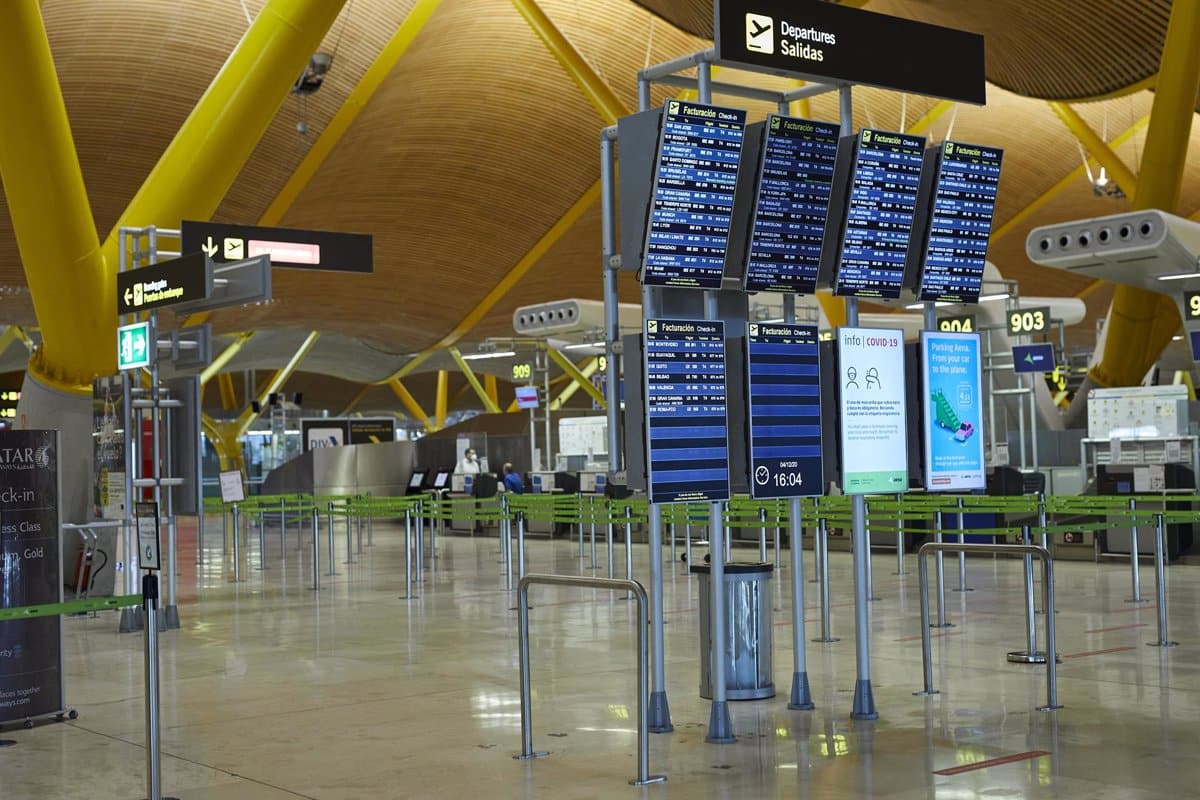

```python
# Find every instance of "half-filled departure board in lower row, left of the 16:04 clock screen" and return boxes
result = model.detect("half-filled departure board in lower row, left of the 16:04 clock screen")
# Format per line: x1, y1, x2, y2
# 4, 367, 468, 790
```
644, 319, 730, 503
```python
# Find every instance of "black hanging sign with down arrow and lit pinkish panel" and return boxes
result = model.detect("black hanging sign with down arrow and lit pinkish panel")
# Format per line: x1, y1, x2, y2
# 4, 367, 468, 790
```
180, 219, 374, 272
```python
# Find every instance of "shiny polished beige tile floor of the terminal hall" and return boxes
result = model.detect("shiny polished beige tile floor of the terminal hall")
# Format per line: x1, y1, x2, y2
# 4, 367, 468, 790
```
0, 525, 1200, 800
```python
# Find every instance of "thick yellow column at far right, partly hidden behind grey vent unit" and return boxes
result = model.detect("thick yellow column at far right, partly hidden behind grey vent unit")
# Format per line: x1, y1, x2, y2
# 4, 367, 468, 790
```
1088, 0, 1200, 386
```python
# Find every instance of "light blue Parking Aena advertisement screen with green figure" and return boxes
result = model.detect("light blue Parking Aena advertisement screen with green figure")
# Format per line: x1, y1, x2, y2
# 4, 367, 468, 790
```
920, 331, 986, 492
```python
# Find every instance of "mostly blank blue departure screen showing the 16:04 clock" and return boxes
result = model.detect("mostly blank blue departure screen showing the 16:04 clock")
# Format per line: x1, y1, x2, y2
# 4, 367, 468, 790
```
746, 323, 824, 498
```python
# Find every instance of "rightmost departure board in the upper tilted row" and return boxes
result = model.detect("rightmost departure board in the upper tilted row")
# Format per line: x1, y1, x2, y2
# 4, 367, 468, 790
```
918, 142, 1003, 302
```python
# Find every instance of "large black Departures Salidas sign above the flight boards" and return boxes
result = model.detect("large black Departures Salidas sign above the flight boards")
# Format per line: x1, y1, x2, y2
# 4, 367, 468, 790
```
713, 0, 986, 106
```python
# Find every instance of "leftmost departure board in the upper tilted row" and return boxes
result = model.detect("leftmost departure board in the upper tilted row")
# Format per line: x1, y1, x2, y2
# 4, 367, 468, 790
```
641, 100, 746, 289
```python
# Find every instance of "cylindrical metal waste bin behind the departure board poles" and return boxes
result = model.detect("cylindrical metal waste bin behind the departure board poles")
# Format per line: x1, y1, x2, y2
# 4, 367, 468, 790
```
691, 564, 775, 700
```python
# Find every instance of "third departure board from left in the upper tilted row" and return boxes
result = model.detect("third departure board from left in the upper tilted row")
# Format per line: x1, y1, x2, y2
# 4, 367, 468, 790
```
834, 128, 925, 300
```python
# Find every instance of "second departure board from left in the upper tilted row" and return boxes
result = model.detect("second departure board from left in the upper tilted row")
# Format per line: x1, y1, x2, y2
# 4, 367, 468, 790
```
745, 114, 839, 294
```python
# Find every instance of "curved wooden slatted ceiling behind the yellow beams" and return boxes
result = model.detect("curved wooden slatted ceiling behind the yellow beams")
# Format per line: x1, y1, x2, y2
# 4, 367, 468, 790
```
0, 0, 1200, 393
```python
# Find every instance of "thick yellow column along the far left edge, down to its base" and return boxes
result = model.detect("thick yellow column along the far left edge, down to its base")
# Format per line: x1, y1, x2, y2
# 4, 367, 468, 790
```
0, 0, 104, 392
